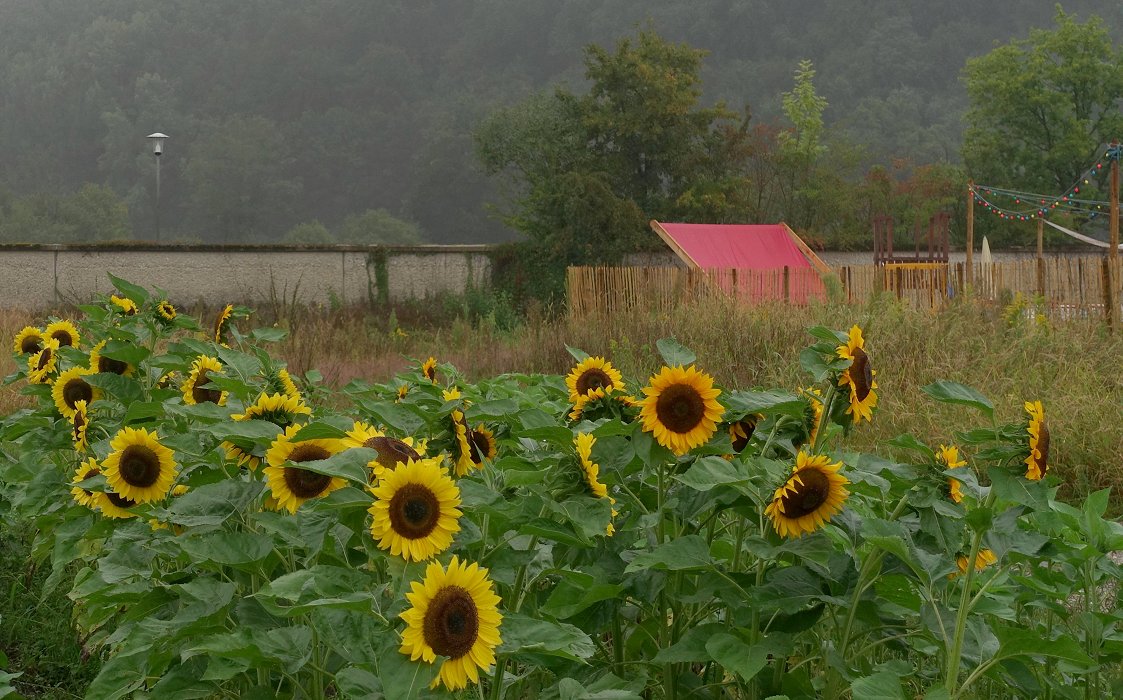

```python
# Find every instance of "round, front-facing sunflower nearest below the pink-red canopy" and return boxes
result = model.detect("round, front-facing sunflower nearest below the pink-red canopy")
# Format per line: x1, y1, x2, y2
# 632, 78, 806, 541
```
639, 365, 724, 455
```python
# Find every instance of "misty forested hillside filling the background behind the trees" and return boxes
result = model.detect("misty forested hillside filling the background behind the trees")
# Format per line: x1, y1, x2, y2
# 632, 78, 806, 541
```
0, 0, 1123, 243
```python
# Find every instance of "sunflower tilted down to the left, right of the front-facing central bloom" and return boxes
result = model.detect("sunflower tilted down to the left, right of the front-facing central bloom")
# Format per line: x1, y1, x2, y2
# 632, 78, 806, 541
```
765, 451, 850, 537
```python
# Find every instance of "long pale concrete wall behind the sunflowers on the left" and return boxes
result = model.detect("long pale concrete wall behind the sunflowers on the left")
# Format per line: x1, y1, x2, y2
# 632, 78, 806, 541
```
0, 245, 494, 309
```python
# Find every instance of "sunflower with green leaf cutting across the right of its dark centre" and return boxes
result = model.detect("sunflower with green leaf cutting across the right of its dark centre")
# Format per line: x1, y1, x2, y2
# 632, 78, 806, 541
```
264, 426, 347, 513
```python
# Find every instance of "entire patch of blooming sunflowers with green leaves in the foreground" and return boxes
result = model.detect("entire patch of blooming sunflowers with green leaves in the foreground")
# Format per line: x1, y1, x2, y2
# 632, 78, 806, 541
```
0, 278, 1123, 700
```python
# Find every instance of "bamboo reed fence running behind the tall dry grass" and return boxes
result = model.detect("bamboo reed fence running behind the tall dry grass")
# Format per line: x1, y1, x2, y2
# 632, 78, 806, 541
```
566, 256, 1121, 325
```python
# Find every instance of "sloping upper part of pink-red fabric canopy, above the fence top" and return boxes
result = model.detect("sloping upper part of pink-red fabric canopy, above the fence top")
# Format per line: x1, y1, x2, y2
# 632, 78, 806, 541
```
659, 222, 811, 270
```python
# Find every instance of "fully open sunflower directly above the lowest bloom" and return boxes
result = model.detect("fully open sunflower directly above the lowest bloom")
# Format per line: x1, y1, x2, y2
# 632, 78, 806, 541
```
369, 457, 462, 562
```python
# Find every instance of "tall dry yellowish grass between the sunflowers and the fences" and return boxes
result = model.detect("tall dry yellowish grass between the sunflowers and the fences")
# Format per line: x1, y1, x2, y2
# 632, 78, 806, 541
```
0, 298, 1123, 497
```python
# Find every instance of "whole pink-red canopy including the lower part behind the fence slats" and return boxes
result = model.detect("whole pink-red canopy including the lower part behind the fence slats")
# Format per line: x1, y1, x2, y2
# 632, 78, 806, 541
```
651, 221, 830, 302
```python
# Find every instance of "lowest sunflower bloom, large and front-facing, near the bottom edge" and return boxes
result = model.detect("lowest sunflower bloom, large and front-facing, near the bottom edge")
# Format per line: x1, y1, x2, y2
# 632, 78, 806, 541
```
399, 556, 503, 690
